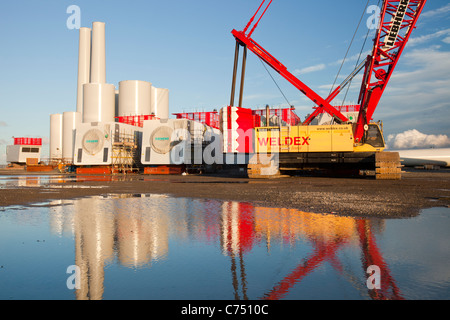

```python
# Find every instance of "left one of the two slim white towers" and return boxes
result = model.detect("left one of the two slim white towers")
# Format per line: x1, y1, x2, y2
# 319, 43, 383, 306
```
77, 28, 91, 114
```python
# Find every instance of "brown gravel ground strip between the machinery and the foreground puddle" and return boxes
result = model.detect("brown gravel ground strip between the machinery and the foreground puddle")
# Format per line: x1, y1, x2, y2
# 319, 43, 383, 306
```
0, 169, 450, 218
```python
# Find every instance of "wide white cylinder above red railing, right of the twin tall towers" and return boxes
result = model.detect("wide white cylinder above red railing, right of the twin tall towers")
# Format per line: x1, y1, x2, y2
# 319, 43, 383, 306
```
118, 80, 152, 117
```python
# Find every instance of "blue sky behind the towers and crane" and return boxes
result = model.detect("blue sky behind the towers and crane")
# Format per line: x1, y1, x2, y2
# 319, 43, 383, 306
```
0, 0, 450, 163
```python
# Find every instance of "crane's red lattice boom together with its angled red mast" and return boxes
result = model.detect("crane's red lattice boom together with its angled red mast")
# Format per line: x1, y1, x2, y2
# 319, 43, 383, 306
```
232, 0, 427, 142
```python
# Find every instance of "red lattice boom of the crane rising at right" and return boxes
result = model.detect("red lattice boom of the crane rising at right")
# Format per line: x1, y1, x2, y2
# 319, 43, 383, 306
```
355, 0, 427, 142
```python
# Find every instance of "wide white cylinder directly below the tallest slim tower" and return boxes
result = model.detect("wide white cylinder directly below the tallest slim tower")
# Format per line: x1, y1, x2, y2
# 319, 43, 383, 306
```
83, 83, 116, 123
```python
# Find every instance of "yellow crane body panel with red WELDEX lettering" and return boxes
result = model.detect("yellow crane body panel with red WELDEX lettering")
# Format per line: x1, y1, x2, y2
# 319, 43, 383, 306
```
255, 125, 353, 153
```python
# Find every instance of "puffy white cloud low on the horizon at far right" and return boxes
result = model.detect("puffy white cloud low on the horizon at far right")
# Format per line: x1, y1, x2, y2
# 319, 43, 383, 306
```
387, 129, 450, 149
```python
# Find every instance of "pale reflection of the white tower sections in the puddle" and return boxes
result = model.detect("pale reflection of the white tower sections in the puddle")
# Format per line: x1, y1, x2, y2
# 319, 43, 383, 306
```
74, 195, 169, 300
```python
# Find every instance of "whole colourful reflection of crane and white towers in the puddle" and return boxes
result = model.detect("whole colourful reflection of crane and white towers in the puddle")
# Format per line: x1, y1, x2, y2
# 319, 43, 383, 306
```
51, 195, 402, 299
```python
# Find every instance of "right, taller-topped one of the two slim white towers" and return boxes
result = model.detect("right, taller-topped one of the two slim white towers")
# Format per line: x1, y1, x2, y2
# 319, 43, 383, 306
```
90, 22, 106, 83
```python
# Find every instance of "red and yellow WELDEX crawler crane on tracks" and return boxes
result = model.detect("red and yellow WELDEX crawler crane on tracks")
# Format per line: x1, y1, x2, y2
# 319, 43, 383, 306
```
230, 0, 426, 179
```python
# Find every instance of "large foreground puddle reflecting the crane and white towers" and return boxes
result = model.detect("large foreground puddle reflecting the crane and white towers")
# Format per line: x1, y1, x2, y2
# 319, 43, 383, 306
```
0, 194, 450, 300
